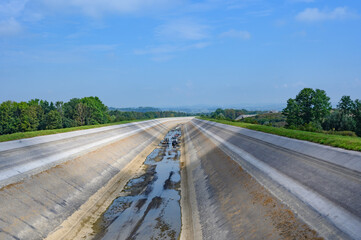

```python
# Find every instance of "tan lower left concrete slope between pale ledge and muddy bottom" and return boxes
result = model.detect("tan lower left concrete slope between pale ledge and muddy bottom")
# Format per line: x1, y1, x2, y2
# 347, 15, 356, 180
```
0, 121, 183, 239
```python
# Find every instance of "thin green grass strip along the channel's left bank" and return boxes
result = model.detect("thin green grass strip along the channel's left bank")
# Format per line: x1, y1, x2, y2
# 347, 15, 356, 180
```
0, 119, 150, 142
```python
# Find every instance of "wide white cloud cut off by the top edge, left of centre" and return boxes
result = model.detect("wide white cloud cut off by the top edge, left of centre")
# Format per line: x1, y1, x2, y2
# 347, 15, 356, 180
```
43, 0, 181, 17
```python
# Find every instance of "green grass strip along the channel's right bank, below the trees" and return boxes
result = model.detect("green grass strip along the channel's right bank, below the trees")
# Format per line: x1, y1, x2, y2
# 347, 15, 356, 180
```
200, 118, 361, 151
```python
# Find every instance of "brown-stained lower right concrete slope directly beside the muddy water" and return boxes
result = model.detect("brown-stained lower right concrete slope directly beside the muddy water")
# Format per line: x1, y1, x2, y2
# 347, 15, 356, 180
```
182, 124, 318, 240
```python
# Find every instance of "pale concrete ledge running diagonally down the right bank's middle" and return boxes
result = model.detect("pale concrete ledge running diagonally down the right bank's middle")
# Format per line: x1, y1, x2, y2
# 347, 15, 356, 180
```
192, 121, 361, 239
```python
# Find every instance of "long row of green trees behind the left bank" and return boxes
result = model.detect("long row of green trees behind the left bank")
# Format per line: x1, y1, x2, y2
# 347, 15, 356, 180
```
0, 97, 188, 135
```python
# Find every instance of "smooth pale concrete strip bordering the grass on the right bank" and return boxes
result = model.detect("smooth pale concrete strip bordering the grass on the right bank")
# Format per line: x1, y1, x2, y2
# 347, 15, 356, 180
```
194, 119, 361, 172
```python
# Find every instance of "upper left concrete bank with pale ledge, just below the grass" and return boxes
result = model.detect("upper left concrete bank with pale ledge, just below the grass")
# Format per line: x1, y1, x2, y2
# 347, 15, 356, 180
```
0, 119, 179, 187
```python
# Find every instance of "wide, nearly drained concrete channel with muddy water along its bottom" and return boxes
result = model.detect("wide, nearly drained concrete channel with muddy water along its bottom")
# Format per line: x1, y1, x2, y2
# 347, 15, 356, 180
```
0, 118, 361, 240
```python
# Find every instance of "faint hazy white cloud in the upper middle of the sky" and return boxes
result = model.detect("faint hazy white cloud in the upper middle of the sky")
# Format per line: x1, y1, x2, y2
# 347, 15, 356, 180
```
156, 19, 209, 40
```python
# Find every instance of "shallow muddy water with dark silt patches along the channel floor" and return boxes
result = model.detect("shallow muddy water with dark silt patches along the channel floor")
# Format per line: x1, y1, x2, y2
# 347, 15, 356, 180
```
94, 127, 181, 239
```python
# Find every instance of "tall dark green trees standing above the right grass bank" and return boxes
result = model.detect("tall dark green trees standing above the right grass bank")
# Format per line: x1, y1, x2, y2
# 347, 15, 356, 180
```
282, 88, 361, 137
